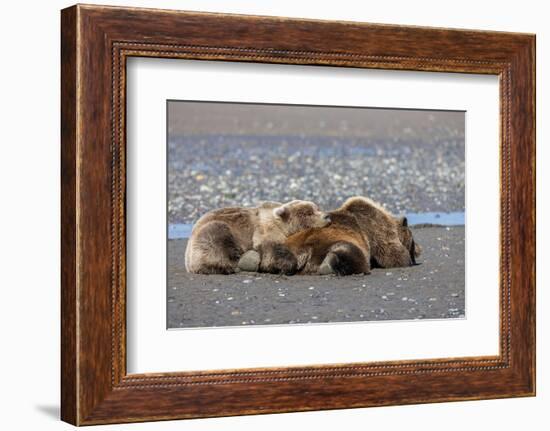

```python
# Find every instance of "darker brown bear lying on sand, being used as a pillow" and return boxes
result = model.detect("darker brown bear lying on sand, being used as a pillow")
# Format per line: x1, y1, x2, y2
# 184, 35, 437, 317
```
285, 197, 421, 275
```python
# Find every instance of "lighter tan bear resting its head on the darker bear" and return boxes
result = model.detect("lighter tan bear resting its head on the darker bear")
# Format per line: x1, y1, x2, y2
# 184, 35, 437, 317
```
185, 200, 330, 274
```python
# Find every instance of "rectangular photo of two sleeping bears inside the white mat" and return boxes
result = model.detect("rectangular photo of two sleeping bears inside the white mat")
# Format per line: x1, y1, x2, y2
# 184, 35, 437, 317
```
166, 100, 467, 329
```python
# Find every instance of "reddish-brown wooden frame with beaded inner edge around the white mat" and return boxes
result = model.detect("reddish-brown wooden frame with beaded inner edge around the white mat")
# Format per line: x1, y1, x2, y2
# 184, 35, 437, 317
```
61, 5, 535, 425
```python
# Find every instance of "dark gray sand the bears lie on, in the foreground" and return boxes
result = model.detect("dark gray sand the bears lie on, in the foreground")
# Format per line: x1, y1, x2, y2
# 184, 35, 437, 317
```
167, 226, 465, 328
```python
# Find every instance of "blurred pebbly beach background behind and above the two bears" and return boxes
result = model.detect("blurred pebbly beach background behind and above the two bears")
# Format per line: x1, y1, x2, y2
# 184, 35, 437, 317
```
168, 102, 465, 224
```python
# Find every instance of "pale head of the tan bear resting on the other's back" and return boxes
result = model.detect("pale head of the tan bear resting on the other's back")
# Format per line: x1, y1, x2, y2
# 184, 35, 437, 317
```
273, 200, 330, 236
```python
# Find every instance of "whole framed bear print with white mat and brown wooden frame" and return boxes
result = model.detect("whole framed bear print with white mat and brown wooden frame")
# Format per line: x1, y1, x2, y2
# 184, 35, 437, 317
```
61, 5, 535, 425
